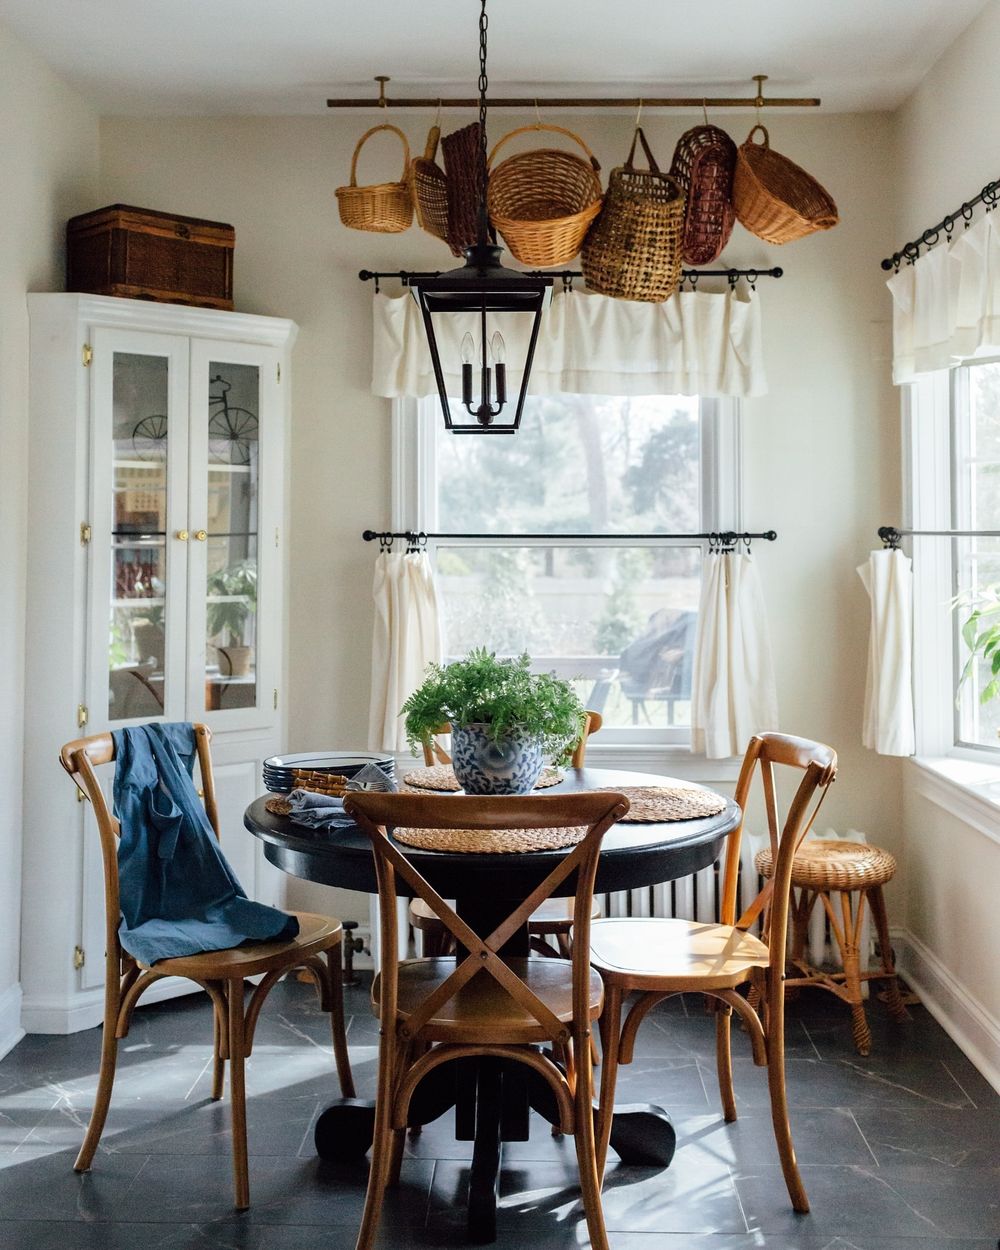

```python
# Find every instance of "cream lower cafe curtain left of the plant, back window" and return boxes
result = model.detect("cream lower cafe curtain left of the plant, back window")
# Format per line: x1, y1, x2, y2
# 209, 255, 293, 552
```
368, 551, 441, 751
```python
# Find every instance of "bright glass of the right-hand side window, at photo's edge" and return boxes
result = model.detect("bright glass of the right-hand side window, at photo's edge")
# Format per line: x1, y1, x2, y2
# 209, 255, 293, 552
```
955, 364, 1000, 749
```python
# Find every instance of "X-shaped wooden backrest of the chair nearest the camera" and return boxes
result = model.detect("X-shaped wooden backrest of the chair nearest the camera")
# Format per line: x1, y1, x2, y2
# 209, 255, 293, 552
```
344, 791, 629, 1043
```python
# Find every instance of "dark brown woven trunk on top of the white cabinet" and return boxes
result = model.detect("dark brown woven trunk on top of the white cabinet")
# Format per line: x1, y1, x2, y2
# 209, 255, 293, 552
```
66, 204, 236, 310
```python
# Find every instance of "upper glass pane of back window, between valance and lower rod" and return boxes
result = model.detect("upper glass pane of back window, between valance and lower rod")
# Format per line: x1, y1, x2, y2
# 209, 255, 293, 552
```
436, 395, 701, 534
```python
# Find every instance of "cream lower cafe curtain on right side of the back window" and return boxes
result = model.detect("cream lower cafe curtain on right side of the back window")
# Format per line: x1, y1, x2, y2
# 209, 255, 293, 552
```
691, 551, 778, 760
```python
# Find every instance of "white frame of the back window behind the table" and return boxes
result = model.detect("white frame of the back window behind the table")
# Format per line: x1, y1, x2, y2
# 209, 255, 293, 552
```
391, 396, 743, 755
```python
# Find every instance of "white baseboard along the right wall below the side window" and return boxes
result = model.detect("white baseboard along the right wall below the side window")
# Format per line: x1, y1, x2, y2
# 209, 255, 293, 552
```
893, 929, 1000, 1091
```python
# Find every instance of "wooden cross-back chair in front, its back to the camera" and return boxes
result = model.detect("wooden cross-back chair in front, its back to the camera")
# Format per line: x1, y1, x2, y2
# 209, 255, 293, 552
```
344, 791, 629, 1250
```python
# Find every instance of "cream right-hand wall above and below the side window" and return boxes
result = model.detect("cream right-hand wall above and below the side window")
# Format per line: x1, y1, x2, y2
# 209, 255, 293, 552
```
886, 0, 1000, 1088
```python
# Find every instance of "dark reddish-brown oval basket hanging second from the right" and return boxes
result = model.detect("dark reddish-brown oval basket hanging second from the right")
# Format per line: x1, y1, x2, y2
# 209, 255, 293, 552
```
670, 125, 736, 265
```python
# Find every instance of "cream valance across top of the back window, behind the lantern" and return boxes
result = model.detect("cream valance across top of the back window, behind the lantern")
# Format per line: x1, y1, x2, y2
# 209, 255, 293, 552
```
371, 291, 768, 399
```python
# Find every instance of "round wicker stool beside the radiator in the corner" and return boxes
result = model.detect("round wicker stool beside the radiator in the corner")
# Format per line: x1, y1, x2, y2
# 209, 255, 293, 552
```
754, 841, 908, 1055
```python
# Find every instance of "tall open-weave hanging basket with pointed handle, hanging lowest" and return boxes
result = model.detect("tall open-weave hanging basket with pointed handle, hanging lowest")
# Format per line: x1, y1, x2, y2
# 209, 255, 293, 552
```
583, 126, 684, 304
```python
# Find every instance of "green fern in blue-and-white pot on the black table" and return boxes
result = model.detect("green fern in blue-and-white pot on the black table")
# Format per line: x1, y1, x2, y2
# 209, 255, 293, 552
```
400, 648, 585, 794
